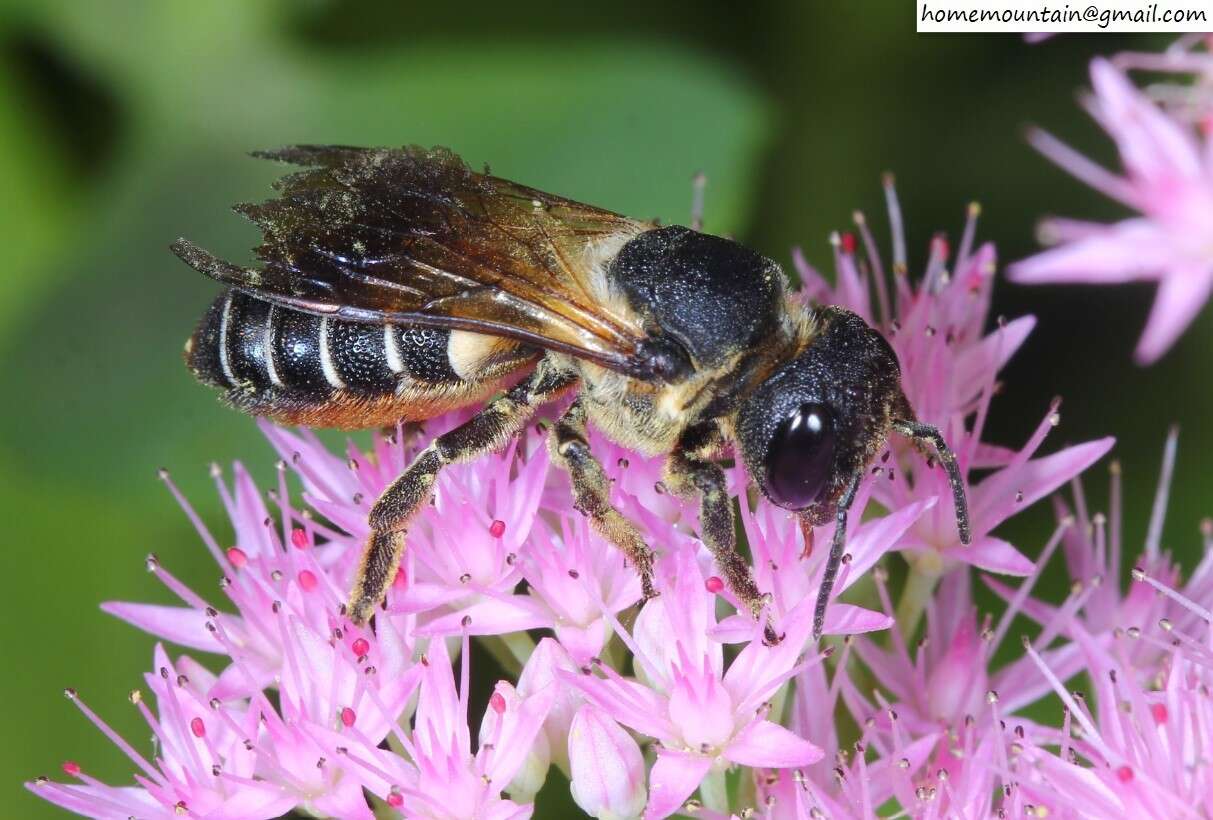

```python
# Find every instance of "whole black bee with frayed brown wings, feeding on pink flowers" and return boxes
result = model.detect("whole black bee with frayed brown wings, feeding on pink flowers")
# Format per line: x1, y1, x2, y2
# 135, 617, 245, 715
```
172, 146, 969, 643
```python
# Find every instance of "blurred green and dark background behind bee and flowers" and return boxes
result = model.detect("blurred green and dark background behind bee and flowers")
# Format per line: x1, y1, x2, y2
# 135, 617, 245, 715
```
0, 0, 1213, 818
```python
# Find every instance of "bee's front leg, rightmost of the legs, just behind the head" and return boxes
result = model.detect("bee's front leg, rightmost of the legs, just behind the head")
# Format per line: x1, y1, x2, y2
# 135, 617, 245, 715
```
664, 431, 784, 647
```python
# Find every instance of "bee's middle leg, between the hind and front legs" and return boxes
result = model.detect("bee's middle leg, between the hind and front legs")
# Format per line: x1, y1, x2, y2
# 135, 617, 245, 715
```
548, 402, 657, 600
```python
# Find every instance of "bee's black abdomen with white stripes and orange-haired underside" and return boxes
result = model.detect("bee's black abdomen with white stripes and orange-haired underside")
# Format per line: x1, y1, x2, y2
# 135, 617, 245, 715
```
186, 291, 535, 428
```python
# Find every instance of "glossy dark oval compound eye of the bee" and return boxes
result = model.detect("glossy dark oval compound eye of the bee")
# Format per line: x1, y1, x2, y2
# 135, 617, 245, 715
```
765, 402, 835, 509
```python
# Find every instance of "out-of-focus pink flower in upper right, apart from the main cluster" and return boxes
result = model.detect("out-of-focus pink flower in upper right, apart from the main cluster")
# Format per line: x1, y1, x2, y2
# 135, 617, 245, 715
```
1010, 59, 1213, 364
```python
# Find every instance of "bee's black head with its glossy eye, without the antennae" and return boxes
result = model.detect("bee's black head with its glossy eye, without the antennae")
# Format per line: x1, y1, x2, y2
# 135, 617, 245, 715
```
738, 307, 912, 523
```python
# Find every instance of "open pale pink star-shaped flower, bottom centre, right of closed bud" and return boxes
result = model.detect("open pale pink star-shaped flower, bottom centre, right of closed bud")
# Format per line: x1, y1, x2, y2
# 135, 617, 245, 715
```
565, 548, 821, 818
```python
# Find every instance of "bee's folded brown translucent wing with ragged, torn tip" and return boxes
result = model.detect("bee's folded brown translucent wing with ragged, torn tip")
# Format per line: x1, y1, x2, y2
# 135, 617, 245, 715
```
172, 146, 654, 372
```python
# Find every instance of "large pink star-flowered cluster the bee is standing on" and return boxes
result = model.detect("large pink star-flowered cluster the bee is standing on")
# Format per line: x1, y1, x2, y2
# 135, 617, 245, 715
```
29, 181, 1174, 820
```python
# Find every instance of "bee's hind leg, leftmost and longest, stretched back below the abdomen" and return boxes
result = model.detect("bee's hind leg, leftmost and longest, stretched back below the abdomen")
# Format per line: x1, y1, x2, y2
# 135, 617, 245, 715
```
346, 361, 576, 623
